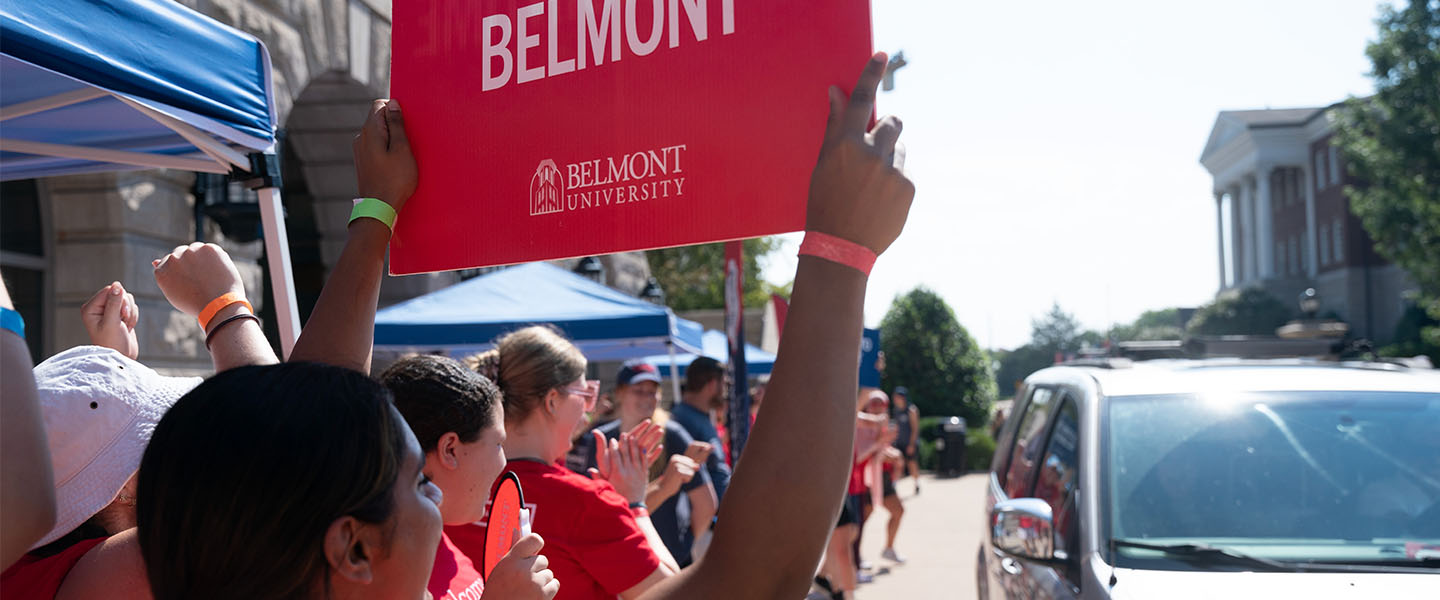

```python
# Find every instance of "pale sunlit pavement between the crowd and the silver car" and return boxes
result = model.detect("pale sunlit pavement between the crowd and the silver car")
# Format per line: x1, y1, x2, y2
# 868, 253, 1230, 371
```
855, 473, 986, 600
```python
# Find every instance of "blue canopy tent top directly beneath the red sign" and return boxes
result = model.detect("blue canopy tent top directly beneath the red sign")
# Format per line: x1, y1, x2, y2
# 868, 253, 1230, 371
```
374, 262, 703, 391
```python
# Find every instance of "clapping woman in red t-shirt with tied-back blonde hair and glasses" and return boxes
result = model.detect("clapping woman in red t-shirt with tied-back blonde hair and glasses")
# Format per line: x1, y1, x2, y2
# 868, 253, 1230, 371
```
460, 327, 678, 600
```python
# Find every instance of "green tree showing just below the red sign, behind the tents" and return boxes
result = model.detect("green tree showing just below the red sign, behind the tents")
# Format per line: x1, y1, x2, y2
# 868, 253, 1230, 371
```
645, 236, 789, 311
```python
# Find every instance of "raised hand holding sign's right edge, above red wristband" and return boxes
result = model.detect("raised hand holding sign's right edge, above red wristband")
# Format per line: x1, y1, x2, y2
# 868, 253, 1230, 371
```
805, 52, 914, 253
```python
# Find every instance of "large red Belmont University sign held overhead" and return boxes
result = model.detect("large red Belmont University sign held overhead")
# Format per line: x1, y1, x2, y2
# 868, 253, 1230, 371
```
390, 0, 871, 275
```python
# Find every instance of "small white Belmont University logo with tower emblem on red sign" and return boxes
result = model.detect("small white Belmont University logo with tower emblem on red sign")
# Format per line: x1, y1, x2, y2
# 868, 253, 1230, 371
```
530, 144, 687, 216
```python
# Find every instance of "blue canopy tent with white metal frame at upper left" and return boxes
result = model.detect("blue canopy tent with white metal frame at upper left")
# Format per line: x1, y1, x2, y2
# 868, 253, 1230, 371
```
0, 0, 300, 354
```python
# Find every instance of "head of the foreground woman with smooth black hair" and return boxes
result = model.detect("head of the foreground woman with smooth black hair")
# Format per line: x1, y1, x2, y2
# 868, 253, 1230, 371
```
137, 363, 441, 600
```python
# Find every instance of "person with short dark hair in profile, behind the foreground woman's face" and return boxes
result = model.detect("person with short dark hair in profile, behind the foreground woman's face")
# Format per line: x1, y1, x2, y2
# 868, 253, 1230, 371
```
380, 354, 560, 600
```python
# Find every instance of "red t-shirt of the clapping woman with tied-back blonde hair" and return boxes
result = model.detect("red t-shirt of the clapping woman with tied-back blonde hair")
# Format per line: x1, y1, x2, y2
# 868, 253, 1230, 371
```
436, 460, 660, 600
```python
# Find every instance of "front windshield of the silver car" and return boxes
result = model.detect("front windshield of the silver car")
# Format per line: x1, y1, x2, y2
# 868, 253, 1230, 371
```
1104, 391, 1440, 568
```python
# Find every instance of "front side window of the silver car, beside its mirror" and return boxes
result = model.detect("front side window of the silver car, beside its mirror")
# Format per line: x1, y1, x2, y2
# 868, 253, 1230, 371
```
1031, 394, 1080, 566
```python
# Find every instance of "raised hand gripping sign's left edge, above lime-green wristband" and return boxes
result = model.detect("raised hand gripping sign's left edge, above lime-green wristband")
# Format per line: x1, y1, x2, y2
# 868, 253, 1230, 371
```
351, 99, 419, 212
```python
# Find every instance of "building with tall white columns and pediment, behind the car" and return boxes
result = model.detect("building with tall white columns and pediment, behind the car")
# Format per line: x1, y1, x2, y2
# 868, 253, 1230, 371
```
1200, 105, 1416, 344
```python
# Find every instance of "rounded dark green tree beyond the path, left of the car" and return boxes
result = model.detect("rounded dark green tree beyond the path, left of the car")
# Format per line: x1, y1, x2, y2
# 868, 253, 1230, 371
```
880, 286, 995, 426
